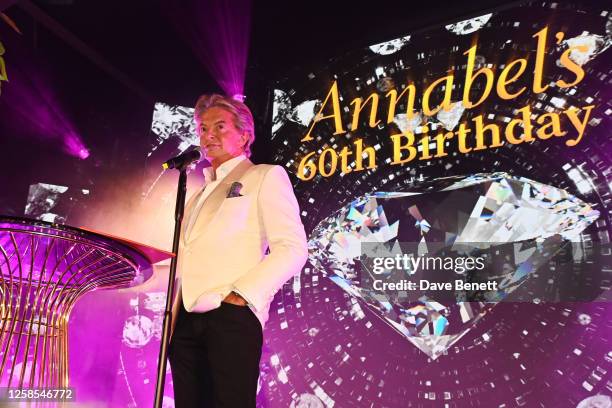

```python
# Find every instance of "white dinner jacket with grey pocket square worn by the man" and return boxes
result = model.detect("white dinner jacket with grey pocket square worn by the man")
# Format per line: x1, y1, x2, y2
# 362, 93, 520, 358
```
172, 158, 308, 327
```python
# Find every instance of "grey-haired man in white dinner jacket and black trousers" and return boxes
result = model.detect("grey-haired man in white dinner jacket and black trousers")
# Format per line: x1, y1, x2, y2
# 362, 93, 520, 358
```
169, 95, 307, 408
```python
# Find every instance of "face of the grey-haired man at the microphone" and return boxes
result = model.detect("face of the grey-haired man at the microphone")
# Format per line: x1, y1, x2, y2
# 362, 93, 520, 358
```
196, 107, 248, 162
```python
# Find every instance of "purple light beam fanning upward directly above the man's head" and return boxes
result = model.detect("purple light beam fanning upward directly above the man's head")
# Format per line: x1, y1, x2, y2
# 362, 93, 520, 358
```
166, 0, 251, 95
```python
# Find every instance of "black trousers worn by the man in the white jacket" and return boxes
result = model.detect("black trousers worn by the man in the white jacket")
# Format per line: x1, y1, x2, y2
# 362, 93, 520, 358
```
168, 302, 263, 408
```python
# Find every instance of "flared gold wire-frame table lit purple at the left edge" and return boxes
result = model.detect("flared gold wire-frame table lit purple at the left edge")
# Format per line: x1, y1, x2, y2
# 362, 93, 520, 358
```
0, 216, 172, 388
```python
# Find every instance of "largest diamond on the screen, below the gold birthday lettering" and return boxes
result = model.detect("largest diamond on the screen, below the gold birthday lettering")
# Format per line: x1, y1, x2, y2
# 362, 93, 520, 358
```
309, 173, 599, 359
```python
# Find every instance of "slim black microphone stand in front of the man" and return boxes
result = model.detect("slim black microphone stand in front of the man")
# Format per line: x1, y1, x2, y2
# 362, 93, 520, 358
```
155, 164, 189, 408
